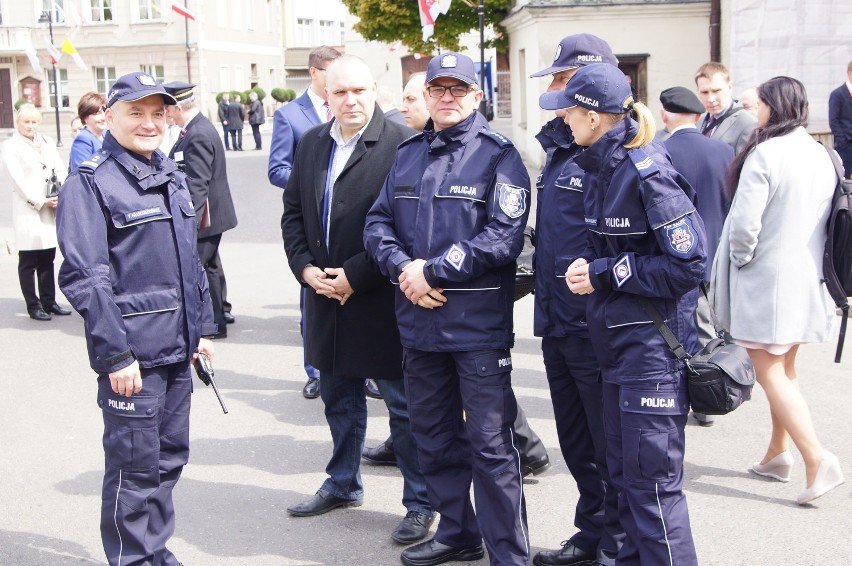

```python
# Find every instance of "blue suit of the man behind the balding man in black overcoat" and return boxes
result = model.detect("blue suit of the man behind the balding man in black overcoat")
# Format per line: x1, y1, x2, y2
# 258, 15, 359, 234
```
266, 91, 322, 378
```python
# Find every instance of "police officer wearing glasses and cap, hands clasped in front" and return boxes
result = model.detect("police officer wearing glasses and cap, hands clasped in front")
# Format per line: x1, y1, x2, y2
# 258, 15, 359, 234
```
364, 52, 530, 566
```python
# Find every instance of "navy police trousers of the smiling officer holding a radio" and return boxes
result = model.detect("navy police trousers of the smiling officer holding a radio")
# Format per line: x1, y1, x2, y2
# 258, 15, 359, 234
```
98, 361, 192, 566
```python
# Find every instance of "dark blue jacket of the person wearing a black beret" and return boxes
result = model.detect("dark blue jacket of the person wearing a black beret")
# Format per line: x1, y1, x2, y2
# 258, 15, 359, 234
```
663, 128, 734, 281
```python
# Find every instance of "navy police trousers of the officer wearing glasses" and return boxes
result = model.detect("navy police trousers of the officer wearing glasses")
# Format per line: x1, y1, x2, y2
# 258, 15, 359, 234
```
403, 348, 530, 566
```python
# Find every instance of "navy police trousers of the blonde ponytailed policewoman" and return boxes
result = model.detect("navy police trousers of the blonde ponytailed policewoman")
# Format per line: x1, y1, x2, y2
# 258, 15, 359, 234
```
603, 377, 698, 566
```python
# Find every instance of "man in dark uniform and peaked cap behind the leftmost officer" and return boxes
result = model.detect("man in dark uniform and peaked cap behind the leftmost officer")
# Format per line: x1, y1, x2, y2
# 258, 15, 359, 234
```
163, 81, 241, 338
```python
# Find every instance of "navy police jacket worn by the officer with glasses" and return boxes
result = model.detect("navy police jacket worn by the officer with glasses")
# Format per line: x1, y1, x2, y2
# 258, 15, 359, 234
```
364, 112, 530, 352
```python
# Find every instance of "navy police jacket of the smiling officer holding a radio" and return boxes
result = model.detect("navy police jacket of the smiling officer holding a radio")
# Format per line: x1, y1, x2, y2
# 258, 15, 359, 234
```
56, 133, 216, 373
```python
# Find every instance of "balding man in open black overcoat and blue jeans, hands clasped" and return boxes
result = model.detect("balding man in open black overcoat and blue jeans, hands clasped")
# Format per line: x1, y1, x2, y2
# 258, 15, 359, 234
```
281, 55, 435, 544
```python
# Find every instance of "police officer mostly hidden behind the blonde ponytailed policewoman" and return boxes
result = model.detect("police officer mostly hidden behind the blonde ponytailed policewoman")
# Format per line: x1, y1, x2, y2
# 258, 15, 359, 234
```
532, 33, 624, 566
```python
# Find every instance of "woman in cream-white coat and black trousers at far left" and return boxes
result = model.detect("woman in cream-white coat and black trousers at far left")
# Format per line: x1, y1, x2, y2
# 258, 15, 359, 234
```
2, 104, 71, 321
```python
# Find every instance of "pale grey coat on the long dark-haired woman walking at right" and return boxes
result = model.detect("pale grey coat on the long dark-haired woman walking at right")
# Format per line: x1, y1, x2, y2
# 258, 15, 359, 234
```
710, 128, 837, 344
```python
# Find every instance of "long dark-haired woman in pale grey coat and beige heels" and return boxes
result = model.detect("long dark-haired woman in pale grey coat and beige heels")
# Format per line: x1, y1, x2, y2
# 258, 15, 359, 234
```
711, 77, 843, 504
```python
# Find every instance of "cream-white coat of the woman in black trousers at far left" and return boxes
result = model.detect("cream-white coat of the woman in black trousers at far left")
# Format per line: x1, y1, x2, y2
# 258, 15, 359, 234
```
0, 132, 68, 250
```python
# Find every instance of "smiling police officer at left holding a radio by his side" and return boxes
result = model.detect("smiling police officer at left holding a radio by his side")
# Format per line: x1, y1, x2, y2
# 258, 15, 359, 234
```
57, 73, 216, 566
